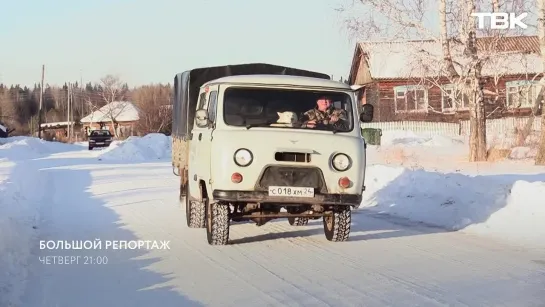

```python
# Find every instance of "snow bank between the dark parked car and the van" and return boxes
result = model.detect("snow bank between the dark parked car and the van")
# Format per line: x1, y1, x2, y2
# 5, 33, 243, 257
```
98, 133, 172, 161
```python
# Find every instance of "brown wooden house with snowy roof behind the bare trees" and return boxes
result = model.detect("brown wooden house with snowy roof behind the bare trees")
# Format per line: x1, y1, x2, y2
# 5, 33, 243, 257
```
349, 36, 544, 122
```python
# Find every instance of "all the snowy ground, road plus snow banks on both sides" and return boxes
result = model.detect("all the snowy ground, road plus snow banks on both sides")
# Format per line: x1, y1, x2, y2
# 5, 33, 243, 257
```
0, 133, 545, 307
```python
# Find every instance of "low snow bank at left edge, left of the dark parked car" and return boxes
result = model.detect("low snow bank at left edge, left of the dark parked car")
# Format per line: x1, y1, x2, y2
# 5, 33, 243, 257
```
0, 136, 81, 161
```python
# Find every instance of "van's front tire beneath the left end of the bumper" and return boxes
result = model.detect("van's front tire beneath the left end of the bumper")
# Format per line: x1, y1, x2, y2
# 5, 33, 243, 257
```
206, 202, 230, 245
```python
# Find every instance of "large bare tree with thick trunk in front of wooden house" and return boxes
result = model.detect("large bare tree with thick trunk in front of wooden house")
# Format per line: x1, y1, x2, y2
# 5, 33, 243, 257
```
341, 0, 525, 161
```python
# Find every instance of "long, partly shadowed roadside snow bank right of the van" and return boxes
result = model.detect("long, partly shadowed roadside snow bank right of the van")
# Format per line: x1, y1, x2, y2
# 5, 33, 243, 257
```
362, 165, 545, 246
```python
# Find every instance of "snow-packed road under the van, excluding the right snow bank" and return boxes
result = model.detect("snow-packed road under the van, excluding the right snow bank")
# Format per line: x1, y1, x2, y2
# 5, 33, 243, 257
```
14, 150, 545, 307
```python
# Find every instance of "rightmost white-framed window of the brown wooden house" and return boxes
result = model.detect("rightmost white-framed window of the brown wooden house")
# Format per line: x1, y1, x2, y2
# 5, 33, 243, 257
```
505, 80, 541, 108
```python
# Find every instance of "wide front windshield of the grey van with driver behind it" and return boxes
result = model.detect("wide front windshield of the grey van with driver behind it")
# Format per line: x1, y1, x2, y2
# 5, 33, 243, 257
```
223, 87, 354, 132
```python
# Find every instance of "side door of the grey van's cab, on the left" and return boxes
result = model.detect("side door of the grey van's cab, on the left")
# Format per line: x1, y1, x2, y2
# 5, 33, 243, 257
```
190, 85, 219, 201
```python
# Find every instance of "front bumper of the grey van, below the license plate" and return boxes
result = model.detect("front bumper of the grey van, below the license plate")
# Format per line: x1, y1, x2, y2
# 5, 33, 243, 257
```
212, 190, 362, 206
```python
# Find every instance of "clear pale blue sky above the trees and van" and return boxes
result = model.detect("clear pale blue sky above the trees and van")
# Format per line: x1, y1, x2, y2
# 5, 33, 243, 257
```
0, 0, 366, 86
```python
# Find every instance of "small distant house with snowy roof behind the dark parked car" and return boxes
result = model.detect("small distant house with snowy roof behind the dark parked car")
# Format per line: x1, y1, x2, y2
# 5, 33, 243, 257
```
80, 101, 140, 137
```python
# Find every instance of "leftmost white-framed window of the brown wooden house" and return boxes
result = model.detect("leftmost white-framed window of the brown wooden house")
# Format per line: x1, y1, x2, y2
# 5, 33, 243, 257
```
394, 85, 428, 113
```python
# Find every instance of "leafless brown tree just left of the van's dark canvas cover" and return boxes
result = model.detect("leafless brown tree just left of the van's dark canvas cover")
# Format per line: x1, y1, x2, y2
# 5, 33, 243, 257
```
132, 84, 172, 133
